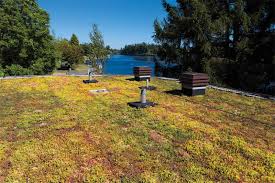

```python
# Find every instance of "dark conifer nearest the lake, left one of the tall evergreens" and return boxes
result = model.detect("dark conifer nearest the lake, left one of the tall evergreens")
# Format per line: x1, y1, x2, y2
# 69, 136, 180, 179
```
154, 0, 218, 70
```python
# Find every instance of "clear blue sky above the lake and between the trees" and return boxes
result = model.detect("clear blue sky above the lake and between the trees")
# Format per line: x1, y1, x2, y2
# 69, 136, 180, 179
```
38, 0, 176, 48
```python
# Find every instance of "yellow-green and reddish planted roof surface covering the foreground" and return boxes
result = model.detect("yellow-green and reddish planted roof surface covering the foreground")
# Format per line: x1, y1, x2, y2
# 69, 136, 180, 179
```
0, 77, 275, 182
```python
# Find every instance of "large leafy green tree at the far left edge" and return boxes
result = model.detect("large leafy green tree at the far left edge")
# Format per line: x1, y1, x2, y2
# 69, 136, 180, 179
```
0, 0, 56, 74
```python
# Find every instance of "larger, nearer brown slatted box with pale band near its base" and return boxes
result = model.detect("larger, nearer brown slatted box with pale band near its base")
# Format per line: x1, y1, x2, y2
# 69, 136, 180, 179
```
180, 72, 209, 96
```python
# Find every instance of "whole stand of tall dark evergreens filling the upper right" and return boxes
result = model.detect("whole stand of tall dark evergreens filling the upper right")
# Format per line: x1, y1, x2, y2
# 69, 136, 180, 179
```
154, 0, 275, 89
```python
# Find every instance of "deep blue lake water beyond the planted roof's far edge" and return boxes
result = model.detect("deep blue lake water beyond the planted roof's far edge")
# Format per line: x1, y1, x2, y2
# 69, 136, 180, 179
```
104, 55, 155, 76
